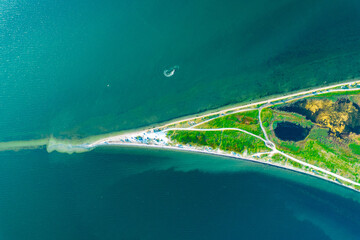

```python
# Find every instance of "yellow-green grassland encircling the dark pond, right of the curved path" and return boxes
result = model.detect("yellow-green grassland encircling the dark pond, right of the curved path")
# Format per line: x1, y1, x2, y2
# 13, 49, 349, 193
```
263, 102, 360, 181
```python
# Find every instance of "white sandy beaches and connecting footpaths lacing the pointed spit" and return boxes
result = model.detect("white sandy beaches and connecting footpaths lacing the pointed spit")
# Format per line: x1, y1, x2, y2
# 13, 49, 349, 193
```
33, 80, 360, 189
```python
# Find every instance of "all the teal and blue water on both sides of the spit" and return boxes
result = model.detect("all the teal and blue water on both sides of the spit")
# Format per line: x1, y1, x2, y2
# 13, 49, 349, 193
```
0, 0, 360, 239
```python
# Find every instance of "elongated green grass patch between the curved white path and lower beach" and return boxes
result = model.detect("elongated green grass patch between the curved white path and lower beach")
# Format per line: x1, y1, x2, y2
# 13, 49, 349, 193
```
168, 130, 269, 154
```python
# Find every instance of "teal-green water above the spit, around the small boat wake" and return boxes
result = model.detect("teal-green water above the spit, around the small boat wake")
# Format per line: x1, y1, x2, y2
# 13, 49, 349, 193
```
0, 0, 360, 144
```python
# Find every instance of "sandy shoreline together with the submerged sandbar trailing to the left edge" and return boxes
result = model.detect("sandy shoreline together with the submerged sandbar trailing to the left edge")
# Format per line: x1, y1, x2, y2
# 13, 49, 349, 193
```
0, 79, 360, 192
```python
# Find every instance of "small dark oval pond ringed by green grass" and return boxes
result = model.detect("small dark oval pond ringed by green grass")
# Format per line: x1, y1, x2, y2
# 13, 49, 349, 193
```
274, 122, 311, 142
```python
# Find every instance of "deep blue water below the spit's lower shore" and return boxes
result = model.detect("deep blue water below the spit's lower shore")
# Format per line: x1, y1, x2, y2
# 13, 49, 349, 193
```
0, 149, 360, 240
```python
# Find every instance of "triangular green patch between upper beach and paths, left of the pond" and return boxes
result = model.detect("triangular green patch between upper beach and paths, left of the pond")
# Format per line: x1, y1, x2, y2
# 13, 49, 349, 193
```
197, 110, 263, 136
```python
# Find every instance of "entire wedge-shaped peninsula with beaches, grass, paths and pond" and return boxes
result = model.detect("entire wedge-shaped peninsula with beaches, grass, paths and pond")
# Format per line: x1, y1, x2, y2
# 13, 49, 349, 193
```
86, 80, 360, 191
